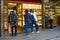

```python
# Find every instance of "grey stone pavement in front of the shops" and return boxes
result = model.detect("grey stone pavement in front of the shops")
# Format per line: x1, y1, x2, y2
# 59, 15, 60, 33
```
0, 27, 60, 40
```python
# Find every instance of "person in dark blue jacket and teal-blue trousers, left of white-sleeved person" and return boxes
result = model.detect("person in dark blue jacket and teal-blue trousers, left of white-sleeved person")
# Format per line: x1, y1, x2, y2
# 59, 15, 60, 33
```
24, 9, 30, 35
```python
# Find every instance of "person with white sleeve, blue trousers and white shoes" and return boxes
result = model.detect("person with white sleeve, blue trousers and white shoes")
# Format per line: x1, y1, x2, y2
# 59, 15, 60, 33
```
30, 9, 39, 33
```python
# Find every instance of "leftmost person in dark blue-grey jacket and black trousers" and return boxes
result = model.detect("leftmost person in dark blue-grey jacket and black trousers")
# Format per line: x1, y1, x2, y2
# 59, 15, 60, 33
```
10, 11, 18, 36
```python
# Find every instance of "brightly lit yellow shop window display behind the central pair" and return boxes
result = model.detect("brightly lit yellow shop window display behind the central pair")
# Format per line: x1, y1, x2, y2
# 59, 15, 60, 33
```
23, 4, 42, 26
